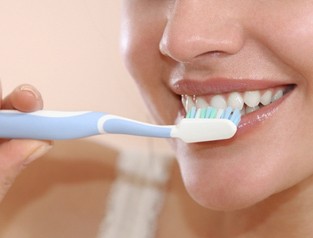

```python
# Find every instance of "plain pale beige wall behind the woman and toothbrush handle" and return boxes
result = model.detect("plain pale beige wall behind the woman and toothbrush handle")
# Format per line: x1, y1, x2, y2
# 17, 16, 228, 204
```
0, 0, 168, 150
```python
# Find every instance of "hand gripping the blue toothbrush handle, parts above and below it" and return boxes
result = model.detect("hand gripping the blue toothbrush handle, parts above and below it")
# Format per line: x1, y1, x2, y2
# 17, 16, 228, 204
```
0, 84, 52, 202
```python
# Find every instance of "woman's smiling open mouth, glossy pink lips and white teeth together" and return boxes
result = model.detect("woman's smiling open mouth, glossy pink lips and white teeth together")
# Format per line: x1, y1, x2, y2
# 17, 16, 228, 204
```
172, 78, 295, 136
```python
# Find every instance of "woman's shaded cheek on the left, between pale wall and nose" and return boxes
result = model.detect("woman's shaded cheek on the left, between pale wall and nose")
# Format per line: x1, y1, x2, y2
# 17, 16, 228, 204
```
122, 14, 177, 124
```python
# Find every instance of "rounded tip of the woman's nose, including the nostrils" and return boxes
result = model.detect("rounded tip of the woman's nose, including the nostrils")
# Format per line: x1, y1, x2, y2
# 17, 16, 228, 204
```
159, 4, 244, 62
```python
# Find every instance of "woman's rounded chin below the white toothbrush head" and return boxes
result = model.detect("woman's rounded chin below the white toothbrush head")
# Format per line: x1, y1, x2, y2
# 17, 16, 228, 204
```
176, 139, 297, 211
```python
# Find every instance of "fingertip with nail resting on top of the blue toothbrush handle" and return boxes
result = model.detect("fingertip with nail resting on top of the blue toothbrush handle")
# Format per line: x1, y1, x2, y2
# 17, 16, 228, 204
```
1, 84, 43, 112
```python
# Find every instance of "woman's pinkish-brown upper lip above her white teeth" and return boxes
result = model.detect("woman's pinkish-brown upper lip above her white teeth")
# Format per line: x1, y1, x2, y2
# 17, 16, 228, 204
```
170, 77, 288, 96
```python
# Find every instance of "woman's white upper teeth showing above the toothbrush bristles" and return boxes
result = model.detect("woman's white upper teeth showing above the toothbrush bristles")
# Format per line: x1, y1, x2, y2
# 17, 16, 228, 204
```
182, 88, 285, 114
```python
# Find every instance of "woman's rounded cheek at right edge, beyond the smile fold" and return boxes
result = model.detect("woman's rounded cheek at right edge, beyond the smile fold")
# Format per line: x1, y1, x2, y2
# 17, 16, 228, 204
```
258, 8, 313, 83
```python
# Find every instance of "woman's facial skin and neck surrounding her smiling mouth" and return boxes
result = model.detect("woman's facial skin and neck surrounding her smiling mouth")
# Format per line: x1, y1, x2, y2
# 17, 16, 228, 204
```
121, 0, 313, 237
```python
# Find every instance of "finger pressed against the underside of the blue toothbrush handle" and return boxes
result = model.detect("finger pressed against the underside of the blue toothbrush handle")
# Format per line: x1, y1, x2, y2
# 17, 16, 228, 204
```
0, 140, 52, 202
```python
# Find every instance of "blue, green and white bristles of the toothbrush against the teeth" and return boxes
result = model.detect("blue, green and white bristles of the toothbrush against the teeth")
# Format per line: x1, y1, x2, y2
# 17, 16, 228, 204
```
186, 107, 241, 126
